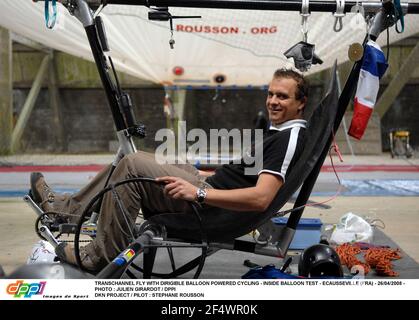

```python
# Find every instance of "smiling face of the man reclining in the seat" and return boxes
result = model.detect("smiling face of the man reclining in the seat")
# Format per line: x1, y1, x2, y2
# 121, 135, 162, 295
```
266, 78, 305, 125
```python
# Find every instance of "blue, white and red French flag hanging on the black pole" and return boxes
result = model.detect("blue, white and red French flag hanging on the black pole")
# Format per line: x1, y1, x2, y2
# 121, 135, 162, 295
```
348, 40, 388, 140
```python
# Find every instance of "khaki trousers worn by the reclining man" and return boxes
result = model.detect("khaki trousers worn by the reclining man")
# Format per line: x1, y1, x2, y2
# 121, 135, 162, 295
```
54, 151, 208, 267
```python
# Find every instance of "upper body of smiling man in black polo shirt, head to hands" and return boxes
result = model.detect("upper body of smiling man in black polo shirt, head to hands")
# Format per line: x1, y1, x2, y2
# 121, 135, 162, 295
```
158, 69, 308, 211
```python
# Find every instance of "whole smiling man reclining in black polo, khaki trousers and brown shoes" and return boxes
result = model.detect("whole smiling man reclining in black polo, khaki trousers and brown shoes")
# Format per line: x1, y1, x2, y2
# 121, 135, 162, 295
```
31, 69, 308, 270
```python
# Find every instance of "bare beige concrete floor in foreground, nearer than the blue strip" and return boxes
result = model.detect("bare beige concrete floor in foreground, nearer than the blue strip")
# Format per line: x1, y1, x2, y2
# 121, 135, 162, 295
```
0, 197, 419, 274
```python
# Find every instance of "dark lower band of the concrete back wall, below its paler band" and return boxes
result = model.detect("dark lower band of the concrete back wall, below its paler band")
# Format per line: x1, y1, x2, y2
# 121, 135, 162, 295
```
13, 67, 419, 154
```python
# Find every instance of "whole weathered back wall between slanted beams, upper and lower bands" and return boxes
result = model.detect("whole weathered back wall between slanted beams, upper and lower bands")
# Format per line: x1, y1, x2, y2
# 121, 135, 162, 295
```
5, 34, 419, 154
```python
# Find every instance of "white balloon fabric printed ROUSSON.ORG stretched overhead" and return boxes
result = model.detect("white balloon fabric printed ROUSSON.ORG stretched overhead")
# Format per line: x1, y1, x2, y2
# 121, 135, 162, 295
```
0, 0, 419, 87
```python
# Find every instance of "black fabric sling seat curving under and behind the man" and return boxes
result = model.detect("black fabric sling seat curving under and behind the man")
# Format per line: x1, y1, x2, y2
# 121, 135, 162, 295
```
149, 64, 339, 242
